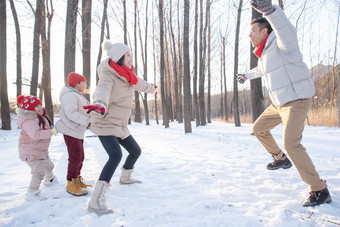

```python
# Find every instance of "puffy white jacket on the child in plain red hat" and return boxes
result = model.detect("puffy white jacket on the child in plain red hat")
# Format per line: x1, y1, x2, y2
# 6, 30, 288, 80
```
55, 86, 90, 139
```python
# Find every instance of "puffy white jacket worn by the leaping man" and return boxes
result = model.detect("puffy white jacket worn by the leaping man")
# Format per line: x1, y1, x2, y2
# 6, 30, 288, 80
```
245, 5, 315, 107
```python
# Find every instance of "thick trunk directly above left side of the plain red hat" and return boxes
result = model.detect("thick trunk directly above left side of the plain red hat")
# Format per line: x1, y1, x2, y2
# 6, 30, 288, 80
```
64, 0, 78, 84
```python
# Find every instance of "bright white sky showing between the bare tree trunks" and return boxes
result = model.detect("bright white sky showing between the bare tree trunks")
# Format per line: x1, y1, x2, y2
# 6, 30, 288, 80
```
3, 0, 340, 101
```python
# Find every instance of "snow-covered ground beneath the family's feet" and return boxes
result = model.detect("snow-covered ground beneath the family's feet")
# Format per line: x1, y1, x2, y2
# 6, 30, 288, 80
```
0, 117, 340, 227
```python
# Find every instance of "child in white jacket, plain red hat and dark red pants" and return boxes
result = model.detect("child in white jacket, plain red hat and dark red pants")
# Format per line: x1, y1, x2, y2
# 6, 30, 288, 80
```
55, 72, 92, 196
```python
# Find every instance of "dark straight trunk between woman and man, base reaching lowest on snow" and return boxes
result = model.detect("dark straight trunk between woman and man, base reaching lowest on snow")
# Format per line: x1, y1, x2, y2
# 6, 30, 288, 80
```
183, 0, 191, 133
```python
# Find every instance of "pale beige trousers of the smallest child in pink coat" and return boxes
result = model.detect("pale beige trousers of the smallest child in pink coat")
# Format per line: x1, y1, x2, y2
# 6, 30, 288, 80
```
27, 158, 54, 192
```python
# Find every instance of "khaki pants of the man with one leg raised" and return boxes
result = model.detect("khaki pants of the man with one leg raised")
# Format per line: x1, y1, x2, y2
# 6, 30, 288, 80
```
253, 99, 326, 191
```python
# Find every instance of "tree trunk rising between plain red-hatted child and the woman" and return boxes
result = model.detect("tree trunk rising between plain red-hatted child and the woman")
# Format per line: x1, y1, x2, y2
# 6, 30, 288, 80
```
81, 0, 92, 101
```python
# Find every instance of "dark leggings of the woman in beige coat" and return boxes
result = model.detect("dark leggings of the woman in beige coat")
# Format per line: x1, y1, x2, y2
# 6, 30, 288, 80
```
98, 135, 141, 182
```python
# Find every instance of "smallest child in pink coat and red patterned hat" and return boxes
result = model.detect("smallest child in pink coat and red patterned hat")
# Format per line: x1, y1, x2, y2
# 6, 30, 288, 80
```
17, 95, 57, 200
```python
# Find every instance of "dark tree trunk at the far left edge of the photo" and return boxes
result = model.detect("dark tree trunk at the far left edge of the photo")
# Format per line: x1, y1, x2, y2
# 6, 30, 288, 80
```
0, 0, 11, 130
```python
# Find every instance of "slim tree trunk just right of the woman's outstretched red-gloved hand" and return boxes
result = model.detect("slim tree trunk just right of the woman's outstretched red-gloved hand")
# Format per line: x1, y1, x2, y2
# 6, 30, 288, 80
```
158, 0, 169, 128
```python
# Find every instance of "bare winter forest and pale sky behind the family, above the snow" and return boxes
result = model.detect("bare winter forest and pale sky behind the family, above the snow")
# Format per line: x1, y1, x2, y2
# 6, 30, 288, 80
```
0, 0, 340, 133
